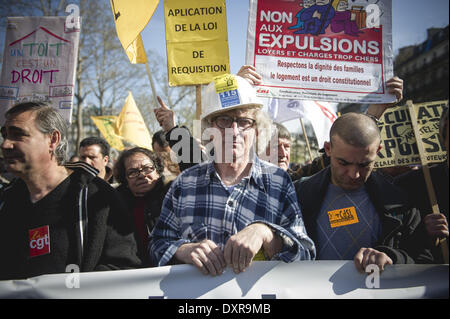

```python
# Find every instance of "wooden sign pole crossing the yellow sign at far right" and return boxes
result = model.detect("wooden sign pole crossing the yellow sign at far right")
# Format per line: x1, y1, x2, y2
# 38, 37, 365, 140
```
406, 100, 448, 264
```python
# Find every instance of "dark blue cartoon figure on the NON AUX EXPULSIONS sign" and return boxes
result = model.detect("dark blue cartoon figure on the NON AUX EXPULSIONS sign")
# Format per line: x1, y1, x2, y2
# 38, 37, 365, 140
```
294, 0, 335, 35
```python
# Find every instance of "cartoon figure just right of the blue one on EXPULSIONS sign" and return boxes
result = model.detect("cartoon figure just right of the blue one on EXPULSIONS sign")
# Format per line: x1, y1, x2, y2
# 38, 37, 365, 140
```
331, 0, 363, 36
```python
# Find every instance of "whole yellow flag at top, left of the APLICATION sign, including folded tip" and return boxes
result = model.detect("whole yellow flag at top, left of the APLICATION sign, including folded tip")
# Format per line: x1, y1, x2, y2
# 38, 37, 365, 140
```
110, 0, 159, 63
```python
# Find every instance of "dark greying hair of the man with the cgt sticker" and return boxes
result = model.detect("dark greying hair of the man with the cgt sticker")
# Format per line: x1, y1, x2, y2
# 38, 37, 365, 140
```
5, 102, 69, 165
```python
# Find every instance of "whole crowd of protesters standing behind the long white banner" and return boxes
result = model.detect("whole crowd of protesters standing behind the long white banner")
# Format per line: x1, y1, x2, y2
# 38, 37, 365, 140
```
0, 0, 449, 300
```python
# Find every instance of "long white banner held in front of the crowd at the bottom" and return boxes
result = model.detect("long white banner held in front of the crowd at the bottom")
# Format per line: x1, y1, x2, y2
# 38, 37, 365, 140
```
0, 260, 448, 300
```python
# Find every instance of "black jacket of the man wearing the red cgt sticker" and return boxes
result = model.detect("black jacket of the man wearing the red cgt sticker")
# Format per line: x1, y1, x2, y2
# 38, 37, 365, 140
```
0, 162, 141, 280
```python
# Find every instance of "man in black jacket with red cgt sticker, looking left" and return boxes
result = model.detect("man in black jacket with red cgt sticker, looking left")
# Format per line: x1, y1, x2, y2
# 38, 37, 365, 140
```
0, 102, 141, 280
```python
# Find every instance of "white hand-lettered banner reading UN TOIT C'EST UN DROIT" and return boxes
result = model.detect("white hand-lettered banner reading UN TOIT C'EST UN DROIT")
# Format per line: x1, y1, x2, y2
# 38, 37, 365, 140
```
0, 16, 80, 123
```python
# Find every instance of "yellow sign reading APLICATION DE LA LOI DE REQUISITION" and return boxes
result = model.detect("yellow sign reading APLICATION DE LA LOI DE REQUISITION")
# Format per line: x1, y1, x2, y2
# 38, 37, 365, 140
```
164, 0, 230, 86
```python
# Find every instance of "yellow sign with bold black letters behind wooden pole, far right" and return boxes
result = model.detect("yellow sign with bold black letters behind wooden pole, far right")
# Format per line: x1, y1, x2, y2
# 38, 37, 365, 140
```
374, 101, 448, 168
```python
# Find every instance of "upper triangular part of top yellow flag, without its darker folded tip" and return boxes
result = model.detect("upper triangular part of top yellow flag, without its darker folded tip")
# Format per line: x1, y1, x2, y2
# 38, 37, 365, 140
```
110, 0, 159, 50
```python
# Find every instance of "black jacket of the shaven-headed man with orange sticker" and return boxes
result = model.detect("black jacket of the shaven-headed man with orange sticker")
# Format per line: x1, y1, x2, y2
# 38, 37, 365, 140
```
294, 167, 424, 264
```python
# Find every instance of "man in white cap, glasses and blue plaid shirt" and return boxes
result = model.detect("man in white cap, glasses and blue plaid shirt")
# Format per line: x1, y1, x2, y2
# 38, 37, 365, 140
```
149, 74, 315, 276
